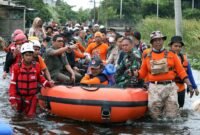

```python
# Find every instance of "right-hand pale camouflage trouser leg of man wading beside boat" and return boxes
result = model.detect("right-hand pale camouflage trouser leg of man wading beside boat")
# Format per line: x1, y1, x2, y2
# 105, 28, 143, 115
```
164, 83, 179, 118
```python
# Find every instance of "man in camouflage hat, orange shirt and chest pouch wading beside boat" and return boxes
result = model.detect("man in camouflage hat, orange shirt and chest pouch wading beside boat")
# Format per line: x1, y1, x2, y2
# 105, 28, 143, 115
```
134, 31, 193, 120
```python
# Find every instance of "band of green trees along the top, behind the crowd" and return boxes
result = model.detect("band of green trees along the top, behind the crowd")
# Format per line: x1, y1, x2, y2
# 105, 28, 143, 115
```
9, 0, 200, 24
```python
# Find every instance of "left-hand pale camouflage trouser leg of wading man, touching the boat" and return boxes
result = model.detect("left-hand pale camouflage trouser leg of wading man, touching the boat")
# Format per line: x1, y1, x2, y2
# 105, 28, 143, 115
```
148, 83, 164, 119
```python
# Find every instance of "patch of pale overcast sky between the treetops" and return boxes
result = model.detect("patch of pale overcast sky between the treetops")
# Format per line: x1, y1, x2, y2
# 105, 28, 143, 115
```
65, 0, 100, 11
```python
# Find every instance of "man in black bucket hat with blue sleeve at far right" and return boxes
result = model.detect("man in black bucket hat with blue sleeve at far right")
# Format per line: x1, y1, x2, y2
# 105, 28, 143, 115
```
169, 36, 199, 107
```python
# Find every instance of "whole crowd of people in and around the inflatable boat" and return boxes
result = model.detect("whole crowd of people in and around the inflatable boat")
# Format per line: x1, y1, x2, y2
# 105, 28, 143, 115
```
1, 17, 199, 119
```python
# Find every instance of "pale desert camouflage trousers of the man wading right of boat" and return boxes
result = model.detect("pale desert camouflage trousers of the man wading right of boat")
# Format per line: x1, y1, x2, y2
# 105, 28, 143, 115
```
148, 82, 179, 119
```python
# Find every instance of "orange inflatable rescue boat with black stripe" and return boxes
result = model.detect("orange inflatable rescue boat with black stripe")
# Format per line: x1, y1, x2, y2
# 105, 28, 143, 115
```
39, 85, 148, 123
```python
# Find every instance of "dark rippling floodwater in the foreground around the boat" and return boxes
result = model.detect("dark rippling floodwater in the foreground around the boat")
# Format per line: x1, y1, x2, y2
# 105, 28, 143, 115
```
0, 51, 200, 135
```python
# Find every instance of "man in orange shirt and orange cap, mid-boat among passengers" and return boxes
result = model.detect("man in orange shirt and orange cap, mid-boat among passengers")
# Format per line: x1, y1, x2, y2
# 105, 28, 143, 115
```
85, 32, 108, 61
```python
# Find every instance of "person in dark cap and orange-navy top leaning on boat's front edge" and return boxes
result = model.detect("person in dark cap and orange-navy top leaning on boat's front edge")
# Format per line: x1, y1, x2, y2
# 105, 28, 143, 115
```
80, 57, 109, 85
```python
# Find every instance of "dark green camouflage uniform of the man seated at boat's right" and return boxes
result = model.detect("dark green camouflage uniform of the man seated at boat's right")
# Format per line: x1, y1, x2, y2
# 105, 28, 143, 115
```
115, 48, 143, 88
